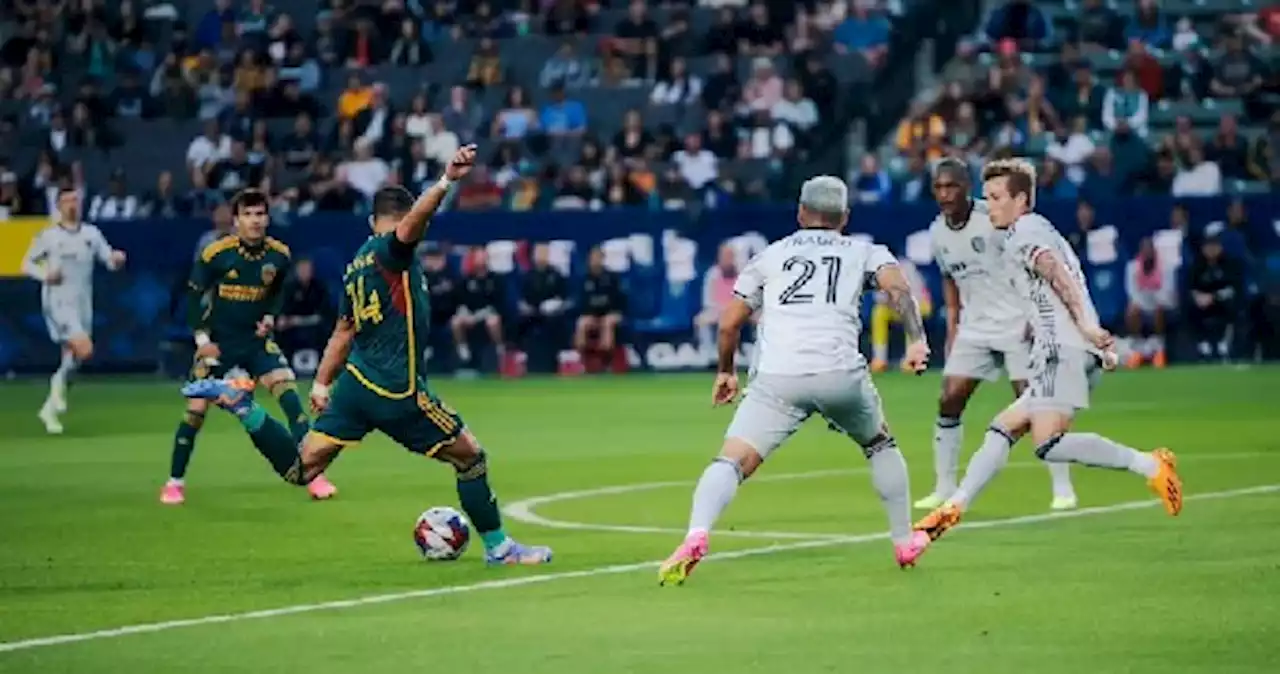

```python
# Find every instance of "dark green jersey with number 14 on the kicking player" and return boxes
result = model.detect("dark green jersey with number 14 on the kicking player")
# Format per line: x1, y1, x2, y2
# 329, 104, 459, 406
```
339, 234, 431, 400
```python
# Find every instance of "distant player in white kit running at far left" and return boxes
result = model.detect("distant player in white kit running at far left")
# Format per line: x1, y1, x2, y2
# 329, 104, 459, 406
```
22, 189, 124, 434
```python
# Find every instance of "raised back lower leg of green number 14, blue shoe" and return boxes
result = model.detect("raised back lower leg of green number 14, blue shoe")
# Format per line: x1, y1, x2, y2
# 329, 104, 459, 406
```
182, 379, 337, 500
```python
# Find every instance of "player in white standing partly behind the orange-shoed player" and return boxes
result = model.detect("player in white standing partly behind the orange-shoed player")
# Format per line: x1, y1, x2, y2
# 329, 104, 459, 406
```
915, 159, 1076, 510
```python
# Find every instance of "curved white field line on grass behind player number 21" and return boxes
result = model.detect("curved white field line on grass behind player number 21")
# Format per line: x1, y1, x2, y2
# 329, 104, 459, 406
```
503, 451, 1280, 541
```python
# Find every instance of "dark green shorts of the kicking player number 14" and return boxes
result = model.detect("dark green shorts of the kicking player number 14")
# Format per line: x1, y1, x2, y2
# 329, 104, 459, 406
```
311, 371, 466, 457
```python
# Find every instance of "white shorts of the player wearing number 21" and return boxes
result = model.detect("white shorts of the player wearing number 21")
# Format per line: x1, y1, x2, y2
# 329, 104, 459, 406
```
724, 368, 884, 458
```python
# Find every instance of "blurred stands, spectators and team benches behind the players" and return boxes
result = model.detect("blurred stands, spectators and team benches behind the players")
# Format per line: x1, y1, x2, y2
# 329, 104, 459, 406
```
0, 0, 1280, 376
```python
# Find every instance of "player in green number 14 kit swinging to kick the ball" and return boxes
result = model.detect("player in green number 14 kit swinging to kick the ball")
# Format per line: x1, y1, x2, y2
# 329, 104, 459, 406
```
183, 146, 552, 564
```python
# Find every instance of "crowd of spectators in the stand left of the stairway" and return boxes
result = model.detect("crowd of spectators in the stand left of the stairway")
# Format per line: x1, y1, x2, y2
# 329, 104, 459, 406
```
0, 0, 890, 220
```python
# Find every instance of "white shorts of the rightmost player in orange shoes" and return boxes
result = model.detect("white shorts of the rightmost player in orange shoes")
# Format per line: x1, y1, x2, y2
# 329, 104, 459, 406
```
1014, 344, 1102, 414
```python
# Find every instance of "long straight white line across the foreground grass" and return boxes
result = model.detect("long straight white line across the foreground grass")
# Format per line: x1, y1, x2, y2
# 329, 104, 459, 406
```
0, 483, 1280, 654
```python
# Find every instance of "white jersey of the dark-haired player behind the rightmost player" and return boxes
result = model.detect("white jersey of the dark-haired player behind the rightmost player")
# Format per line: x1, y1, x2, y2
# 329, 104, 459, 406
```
929, 200, 1030, 340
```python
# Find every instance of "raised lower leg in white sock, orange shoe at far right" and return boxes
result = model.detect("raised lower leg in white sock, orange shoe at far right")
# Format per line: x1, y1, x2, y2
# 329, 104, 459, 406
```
1036, 432, 1183, 515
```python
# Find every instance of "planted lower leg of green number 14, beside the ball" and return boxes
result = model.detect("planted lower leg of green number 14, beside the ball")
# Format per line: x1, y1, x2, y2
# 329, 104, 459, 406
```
434, 430, 552, 565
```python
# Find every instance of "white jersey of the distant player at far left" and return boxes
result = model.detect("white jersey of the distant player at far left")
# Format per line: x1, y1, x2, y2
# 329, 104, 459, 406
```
22, 224, 111, 307
